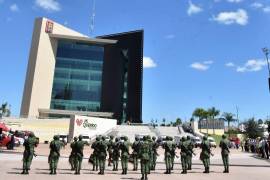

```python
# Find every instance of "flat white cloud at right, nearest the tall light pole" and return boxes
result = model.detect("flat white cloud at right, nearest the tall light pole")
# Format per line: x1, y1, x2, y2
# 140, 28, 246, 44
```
236, 59, 267, 73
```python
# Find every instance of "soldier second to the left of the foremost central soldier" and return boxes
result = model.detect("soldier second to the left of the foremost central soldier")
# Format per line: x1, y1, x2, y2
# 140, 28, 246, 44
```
120, 136, 130, 174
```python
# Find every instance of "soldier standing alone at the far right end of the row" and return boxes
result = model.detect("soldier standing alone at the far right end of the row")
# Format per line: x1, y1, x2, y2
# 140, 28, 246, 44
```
219, 135, 230, 173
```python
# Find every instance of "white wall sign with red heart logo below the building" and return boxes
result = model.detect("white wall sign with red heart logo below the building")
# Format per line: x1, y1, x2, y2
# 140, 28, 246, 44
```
69, 115, 117, 141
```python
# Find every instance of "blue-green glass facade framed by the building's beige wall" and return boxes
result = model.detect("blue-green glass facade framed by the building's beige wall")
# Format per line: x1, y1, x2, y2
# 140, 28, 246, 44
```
50, 40, 104, 111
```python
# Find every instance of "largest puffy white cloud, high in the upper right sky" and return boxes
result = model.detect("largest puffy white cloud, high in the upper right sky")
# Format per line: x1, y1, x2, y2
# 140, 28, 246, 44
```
212, 9, 248, 26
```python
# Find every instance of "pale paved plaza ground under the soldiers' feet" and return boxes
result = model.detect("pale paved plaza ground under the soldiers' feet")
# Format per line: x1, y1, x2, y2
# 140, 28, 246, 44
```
0, 145, 270, 180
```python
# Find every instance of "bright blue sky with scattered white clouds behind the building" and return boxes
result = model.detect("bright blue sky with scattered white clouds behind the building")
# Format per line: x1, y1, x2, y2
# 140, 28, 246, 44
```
0, 0, 270, 122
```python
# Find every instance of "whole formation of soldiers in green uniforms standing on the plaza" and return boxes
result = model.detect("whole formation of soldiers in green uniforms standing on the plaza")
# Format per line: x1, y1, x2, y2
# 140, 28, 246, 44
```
22, 133, 230, 180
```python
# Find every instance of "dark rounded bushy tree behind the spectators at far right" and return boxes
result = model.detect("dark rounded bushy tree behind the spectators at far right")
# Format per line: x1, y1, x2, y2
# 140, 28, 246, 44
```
244, 118, 263, 139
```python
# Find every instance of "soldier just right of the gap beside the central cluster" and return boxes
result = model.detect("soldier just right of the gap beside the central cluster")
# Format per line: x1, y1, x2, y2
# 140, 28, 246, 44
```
162, 136, 173, 174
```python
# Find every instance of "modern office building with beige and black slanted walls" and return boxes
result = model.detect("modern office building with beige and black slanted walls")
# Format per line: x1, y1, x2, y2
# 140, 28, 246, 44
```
21, 18, 143, 123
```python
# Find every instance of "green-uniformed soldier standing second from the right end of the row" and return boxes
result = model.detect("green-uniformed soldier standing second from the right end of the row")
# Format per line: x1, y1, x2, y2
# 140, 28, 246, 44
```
200, 136, 211, 173
